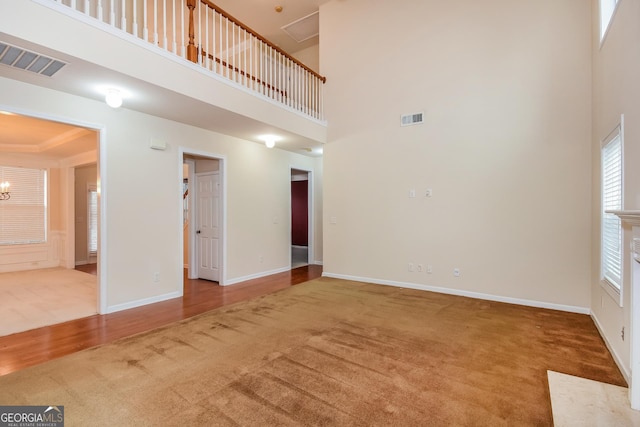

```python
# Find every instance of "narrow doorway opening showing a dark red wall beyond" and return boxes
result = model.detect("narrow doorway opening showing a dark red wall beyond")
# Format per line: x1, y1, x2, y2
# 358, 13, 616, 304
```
291, 168, 313, 269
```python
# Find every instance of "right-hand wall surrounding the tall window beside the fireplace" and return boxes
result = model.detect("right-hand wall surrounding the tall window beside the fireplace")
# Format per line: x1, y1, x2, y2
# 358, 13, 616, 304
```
591, 0, 640, 378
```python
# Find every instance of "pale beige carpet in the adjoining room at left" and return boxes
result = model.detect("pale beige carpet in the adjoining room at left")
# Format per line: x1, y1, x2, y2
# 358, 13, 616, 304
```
0, 268, 97, 336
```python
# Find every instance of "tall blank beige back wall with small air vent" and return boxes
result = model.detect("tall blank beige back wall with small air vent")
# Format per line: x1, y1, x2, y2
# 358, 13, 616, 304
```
320, 0, 592, 312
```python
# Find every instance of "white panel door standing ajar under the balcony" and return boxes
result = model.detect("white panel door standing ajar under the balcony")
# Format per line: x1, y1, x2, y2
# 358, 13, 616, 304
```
196, 172, 220, 282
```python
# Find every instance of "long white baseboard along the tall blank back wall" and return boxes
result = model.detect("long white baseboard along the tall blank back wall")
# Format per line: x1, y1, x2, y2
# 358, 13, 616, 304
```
322, 272, 591, 314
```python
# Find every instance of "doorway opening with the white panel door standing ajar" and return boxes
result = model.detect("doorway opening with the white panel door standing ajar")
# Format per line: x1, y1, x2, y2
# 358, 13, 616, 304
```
180, 150, 225, 285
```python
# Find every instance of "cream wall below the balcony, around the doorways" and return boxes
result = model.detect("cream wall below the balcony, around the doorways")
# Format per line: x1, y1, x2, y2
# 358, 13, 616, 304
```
0, 78, 321, 310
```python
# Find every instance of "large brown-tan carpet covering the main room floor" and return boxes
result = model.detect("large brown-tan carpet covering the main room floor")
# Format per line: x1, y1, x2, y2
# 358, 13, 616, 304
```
0, 278, 624, 426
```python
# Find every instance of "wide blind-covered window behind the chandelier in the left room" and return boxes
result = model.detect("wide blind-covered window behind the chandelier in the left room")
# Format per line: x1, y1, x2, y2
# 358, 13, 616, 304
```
0, 166, 47, 245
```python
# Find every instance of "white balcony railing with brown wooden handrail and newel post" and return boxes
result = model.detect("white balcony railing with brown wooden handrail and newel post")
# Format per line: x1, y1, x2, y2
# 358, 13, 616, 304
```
51, 0, 326, 120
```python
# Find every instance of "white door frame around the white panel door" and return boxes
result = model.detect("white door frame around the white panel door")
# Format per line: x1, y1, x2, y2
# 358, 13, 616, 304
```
178, 146, 227, 291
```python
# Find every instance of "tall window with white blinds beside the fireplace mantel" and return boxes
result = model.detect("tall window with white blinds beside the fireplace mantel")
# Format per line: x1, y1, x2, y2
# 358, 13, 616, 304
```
602, 126, 622, 294
